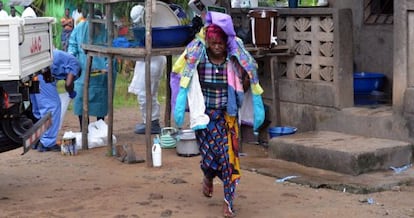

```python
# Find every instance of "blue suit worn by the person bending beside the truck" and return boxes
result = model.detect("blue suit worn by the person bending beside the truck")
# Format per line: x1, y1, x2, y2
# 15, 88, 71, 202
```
30, 49, 80, 147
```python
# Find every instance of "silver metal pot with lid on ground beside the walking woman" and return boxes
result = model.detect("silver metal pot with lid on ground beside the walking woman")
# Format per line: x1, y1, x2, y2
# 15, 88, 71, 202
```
176, 129, 200, 157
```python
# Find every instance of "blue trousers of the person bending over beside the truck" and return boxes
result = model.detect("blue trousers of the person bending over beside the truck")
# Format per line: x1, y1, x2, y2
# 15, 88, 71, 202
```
30, 75, 61, 147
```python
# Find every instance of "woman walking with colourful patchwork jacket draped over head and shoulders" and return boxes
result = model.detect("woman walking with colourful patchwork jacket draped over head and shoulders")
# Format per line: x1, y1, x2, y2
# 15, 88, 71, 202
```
174, 12, 265, 217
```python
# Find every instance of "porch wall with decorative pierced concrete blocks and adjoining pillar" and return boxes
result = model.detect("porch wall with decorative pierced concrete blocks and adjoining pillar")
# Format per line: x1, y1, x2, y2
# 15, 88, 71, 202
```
232, 8, 353, 131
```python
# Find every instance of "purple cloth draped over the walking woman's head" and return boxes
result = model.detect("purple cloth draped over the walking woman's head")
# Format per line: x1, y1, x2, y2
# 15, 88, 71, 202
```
206, 11, 237, 51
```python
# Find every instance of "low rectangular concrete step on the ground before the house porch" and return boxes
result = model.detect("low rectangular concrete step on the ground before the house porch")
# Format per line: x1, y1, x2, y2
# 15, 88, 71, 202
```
269, 131, 413, 175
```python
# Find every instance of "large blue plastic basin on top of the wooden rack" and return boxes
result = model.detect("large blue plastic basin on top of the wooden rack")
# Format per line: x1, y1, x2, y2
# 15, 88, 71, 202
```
132, 25, 192, 48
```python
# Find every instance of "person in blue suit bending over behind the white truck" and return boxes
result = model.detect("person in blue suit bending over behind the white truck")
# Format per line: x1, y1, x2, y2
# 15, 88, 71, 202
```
30, 49, 81, 152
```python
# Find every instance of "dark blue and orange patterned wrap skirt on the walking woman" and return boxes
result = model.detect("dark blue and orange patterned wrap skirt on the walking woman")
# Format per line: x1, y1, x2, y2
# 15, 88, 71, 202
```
196, 109, 240, 209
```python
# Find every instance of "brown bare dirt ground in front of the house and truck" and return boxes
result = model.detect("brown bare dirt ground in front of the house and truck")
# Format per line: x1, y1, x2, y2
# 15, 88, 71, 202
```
0, 108, 414, 218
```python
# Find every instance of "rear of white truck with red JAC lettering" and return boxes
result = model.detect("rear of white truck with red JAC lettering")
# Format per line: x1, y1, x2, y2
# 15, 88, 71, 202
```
0, 17, 55, 153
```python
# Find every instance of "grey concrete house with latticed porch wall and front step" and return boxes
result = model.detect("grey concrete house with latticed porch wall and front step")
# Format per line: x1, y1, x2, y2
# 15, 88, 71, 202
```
232, 0, 414, 174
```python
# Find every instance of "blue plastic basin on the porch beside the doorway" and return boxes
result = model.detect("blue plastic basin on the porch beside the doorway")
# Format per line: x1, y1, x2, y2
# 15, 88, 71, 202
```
354, 72, 385, 94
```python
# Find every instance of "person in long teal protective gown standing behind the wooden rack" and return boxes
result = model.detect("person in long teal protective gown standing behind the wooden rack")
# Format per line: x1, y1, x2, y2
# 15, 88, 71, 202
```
68, 9, 116, 130
